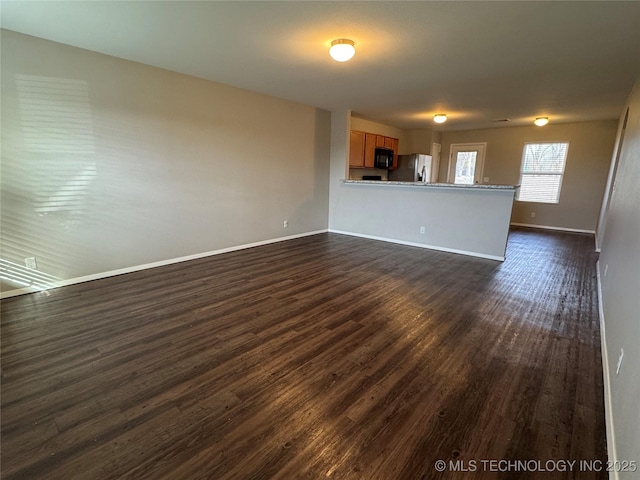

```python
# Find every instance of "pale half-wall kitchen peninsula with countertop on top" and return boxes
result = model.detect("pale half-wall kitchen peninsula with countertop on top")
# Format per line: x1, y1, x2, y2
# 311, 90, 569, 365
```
331, 180, 518, 261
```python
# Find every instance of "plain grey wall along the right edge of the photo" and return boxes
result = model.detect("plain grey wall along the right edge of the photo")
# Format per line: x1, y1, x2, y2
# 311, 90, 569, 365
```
598, 78, 640, 472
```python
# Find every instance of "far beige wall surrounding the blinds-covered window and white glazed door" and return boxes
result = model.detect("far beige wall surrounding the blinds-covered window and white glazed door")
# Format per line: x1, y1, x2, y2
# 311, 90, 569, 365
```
439, 120, 617, 231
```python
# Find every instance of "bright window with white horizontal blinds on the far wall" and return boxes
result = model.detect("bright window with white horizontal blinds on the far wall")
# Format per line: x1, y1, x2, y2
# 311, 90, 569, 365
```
518, 142, 569, 203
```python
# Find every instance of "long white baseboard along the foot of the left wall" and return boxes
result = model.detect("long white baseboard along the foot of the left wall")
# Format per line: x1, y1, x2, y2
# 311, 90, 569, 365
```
0, 229, 328, 299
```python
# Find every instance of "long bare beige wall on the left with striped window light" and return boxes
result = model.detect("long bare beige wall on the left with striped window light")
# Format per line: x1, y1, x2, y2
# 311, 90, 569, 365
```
1, 31, 331, 292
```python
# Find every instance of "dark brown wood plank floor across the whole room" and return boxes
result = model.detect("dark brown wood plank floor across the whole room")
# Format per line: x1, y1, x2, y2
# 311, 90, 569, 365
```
1, 230, 607, 480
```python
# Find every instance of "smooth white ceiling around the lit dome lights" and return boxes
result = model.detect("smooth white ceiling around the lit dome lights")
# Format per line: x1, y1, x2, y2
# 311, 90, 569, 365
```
0, 0, 640, 130
